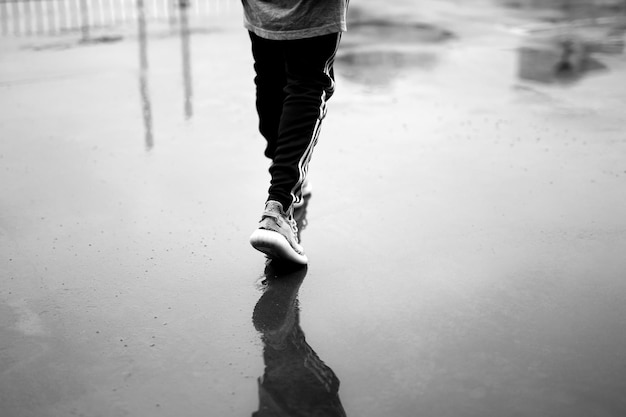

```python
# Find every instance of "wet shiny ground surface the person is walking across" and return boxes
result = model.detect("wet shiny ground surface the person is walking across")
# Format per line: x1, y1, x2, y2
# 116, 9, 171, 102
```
0, 0, 626, 417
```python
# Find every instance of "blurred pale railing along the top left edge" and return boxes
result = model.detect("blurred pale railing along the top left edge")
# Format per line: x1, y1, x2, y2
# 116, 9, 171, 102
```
0, 0, 236, 36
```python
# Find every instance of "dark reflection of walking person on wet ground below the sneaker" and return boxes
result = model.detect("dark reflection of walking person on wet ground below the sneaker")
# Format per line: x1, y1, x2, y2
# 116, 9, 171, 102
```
252, 261, 346, 417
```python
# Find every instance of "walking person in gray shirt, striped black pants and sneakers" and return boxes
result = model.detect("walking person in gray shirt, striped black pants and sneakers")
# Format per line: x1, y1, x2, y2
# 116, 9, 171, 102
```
242, 0, 348, 264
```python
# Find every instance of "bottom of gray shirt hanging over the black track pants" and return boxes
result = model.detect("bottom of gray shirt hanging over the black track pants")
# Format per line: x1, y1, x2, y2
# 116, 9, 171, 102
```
241, 0, 349, 40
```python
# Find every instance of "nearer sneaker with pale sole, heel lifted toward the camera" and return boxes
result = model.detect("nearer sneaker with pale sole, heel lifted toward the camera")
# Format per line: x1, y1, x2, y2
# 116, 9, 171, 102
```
250, 200, 308, 265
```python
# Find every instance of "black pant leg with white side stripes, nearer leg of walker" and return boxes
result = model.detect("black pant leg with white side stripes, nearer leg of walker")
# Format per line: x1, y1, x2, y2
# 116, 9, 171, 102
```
268, 33, 340, 211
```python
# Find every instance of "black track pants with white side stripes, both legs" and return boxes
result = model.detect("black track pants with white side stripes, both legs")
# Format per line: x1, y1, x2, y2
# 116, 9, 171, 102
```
250, 33, 341, 210
